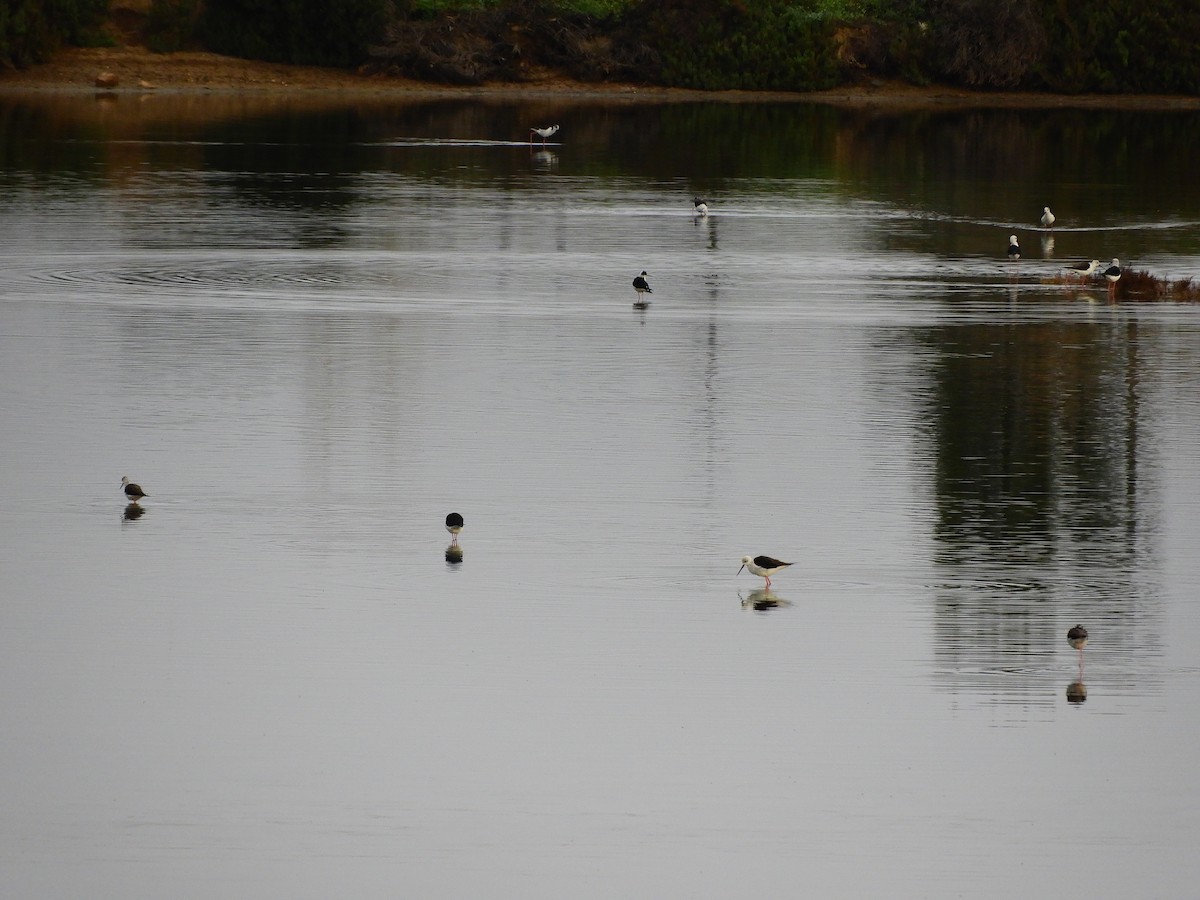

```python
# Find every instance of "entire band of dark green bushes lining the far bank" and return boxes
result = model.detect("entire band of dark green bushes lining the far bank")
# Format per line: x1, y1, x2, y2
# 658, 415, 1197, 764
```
0, 0, 1200, 94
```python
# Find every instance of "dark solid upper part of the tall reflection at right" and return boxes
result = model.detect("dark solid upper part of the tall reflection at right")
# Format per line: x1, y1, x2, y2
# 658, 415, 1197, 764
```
928, 322, 1140, 562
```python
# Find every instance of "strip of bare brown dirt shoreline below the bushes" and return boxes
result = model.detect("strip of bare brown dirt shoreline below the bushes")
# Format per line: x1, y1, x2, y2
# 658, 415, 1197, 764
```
0, 46, 1200, 110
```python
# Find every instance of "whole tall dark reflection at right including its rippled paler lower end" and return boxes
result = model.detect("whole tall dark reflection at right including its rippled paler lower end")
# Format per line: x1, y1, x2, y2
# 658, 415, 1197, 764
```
920, 316, 1160, 709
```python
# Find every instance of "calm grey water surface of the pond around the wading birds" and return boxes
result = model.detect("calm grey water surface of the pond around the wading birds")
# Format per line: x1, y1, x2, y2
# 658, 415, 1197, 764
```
0, 95, 1200, 898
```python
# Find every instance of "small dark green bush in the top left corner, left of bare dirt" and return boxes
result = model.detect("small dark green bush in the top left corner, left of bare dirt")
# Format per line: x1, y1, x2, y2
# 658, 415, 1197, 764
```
0, 0, 108, 68
